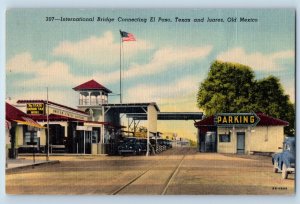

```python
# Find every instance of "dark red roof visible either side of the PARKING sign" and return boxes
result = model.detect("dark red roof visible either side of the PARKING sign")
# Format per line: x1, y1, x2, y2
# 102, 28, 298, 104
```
194, 113, 289, 127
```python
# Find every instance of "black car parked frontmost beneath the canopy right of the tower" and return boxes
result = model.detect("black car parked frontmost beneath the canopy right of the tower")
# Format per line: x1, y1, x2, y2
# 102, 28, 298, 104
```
118, 137, 142, 155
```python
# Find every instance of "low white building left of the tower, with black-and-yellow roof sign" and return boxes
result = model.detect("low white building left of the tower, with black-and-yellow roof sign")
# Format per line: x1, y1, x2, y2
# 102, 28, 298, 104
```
17, 100, 105, 154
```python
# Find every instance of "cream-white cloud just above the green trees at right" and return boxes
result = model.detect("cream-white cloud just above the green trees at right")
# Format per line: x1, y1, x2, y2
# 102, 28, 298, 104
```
217, 48, 295, 71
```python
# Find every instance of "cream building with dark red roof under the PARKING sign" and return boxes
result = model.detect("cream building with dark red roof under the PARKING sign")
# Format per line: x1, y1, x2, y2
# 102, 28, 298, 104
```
195, 113, 289, 154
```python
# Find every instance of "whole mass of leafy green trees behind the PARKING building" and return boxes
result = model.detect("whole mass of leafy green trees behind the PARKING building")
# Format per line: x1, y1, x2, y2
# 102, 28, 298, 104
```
197, 61, 295, 135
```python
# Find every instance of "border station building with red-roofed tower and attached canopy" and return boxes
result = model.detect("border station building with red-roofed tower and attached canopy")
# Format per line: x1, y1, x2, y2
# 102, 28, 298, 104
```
11, 80, 202, 154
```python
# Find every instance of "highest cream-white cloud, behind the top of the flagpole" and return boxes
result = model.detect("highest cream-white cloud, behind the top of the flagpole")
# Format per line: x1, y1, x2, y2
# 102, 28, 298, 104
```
52, 31, 153, 69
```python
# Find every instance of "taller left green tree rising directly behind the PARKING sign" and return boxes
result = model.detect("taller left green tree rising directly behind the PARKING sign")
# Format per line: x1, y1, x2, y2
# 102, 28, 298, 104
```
197, 61, 255, 115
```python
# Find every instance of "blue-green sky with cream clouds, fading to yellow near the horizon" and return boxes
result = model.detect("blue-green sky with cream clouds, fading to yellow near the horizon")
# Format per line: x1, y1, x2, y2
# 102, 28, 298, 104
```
6, 9, 295, 139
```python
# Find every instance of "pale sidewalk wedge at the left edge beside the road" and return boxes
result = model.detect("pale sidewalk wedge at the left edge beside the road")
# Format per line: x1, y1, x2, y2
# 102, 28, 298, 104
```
5, 159, 59, 173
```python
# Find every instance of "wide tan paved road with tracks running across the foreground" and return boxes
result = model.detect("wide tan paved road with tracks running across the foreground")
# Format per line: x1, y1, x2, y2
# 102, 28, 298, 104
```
6, 148, 294, 195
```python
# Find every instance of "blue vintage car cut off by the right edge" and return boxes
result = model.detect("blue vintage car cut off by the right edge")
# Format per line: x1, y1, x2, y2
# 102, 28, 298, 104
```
272, 137, 296, 179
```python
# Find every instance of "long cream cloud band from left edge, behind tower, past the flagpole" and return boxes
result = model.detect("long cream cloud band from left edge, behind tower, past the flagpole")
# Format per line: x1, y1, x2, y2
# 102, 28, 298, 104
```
7, 43, 212, 103
